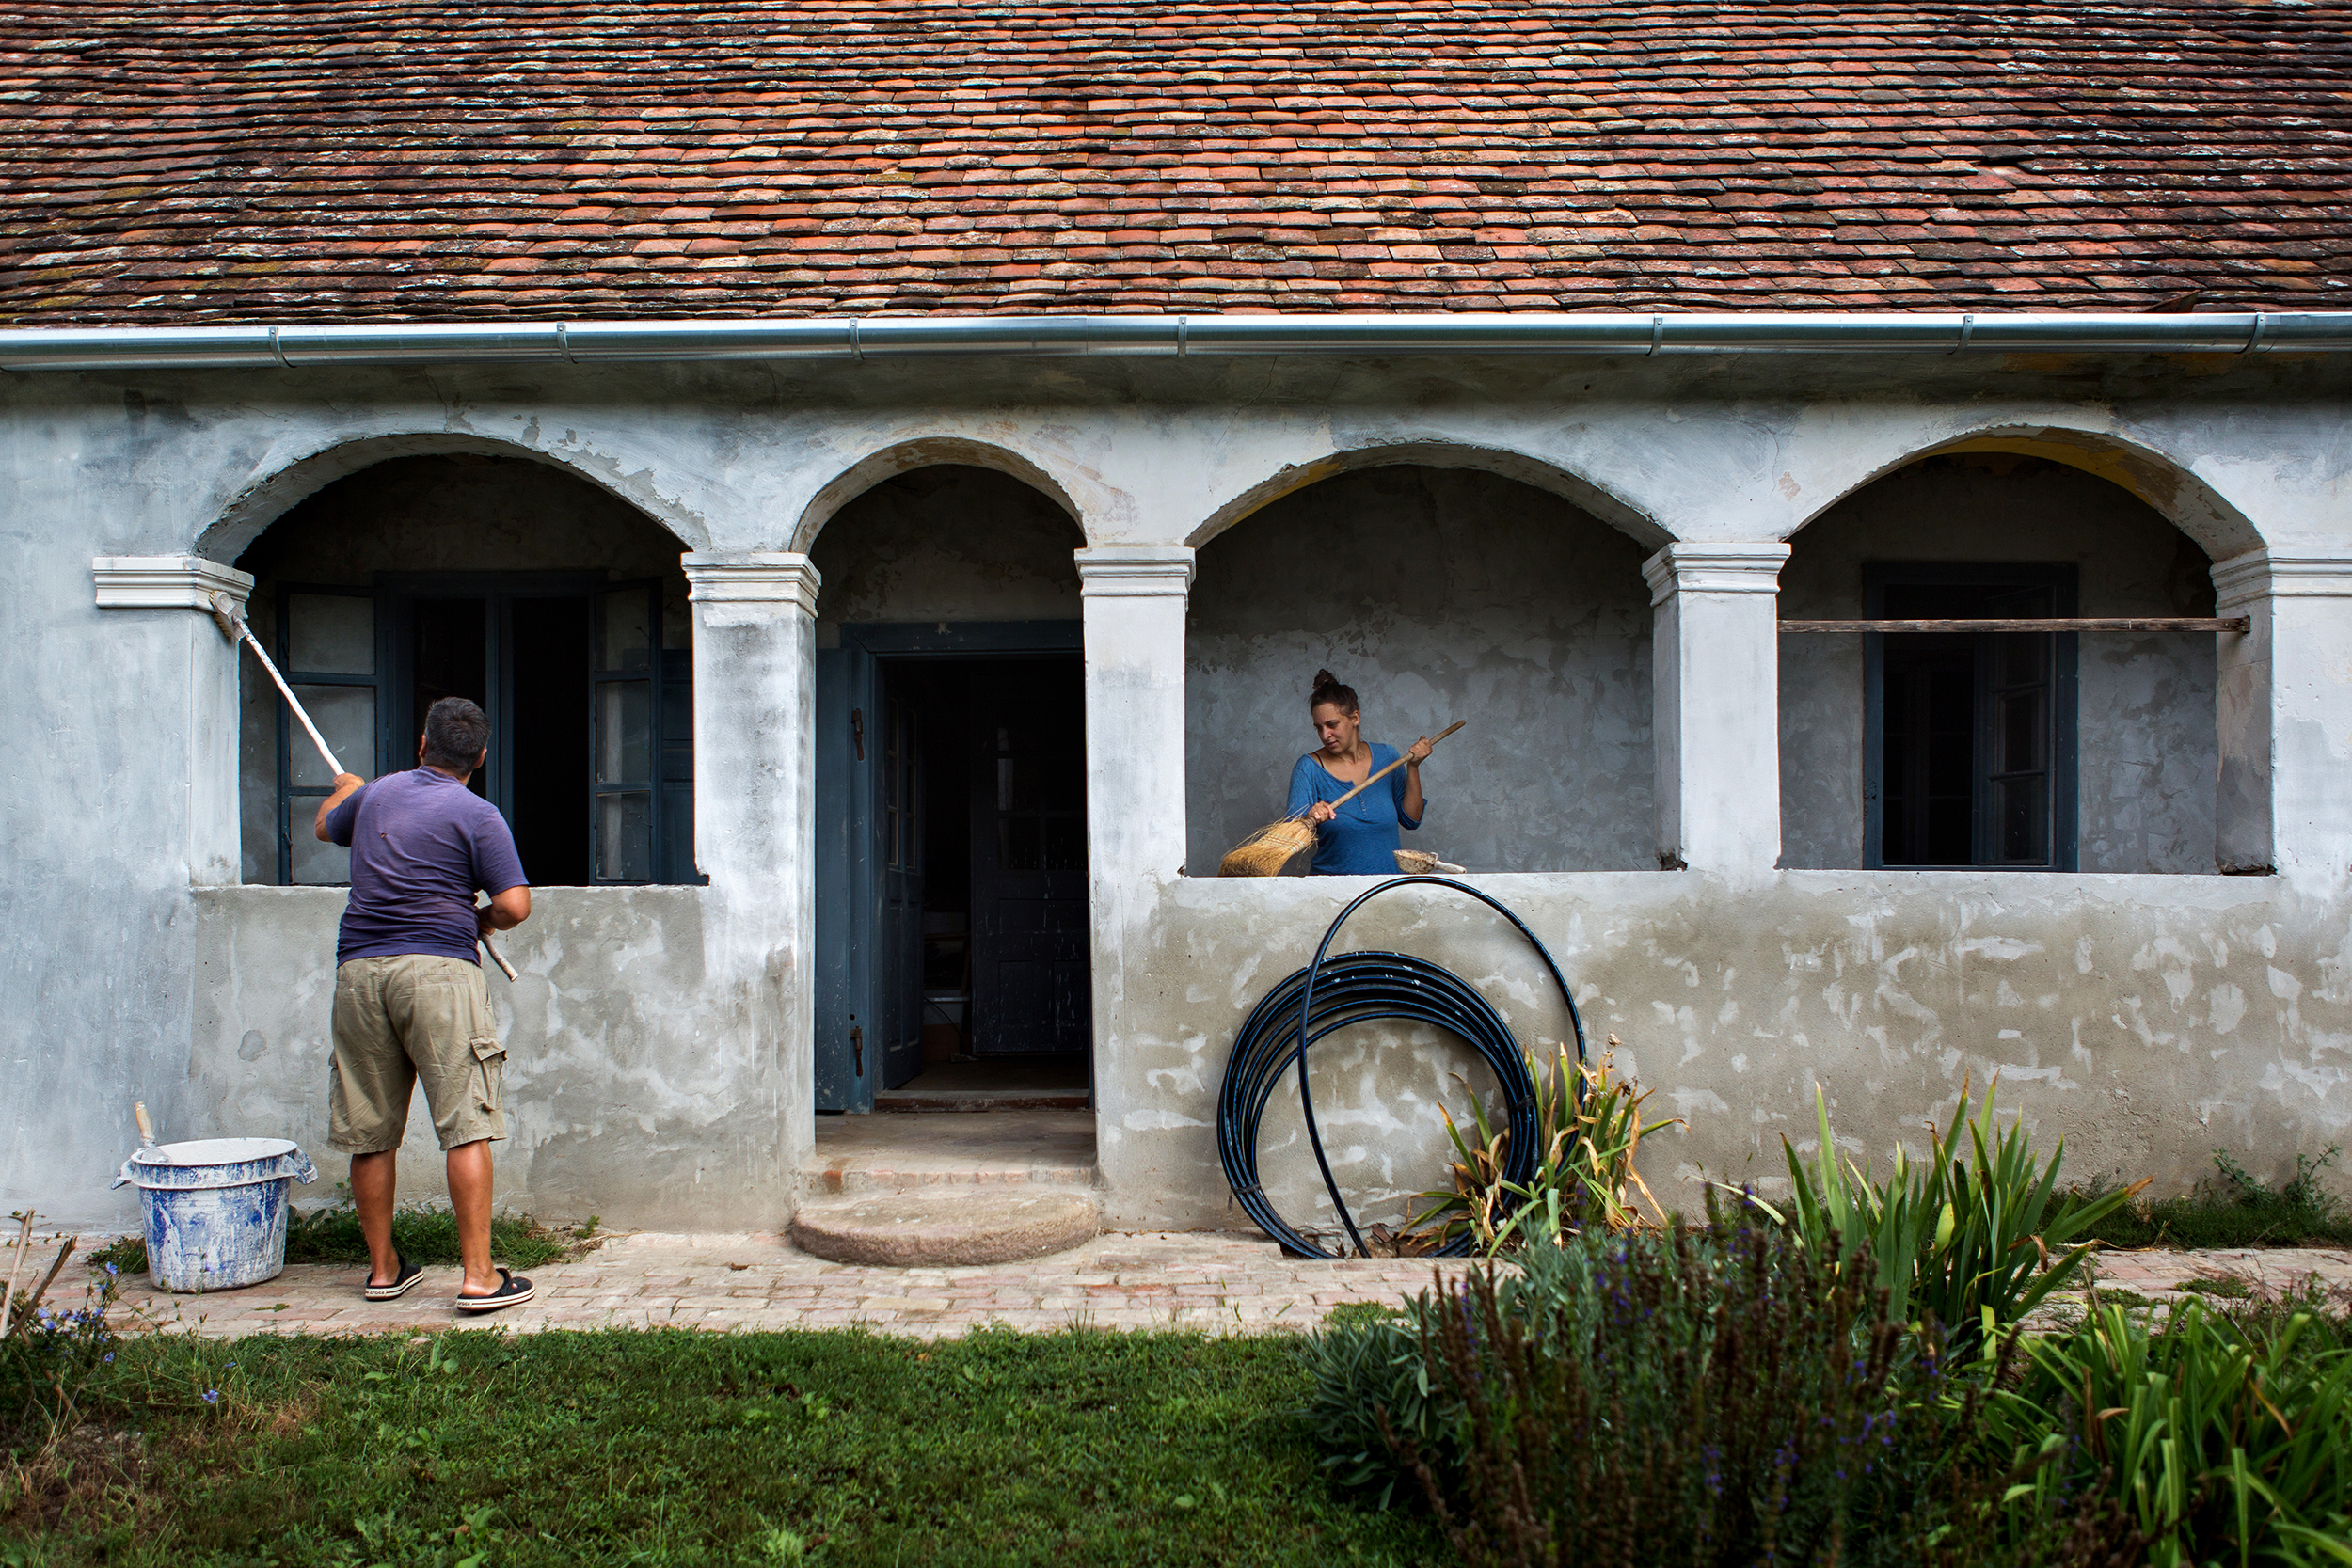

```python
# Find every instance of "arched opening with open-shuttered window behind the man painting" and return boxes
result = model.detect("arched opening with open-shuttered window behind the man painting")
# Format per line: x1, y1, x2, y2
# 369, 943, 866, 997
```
235, 451, 696, 886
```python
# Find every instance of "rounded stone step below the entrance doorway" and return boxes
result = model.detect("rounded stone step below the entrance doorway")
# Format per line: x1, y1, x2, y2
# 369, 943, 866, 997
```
793, 1187, 1104, 1270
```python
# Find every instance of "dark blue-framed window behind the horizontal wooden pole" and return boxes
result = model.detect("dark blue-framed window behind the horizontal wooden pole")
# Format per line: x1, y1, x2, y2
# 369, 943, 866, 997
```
1863, 562, 2079, 872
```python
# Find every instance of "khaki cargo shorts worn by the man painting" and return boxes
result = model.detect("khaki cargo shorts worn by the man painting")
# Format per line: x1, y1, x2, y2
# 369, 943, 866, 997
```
327, 952, 506, 1154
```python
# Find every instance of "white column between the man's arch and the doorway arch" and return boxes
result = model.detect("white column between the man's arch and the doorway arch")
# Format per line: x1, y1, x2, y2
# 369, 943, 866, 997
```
682, 550, 818, 1175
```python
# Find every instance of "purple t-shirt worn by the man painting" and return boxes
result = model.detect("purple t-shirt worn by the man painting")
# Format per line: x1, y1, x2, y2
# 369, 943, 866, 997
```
327, 768, 525, 964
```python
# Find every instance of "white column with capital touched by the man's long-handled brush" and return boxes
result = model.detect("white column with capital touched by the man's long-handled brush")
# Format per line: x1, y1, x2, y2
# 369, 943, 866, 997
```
89, 555, 268, 886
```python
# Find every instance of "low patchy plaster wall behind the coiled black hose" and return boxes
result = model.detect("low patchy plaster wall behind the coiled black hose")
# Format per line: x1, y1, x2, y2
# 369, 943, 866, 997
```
1099, 872, 2352, 1229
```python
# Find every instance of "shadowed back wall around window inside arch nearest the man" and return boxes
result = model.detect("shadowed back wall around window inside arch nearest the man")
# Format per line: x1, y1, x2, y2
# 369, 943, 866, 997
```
238, 453, 694, 884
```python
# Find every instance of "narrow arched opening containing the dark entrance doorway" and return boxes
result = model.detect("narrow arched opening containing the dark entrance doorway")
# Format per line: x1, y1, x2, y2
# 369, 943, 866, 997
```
809, 463, 1094, 1114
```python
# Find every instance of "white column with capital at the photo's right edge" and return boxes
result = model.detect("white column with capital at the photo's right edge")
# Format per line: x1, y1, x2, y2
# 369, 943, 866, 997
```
2214, 550, 2352, 879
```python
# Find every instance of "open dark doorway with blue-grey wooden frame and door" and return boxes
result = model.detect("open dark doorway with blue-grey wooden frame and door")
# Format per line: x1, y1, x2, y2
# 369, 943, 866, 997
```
817, 623, 1094, 1110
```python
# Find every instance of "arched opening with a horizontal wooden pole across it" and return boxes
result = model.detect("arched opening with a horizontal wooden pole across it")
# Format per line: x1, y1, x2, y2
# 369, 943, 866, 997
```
1781, 451, 2218, 872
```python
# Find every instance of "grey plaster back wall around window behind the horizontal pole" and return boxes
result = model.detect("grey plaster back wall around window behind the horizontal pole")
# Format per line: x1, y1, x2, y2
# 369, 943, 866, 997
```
1781, 453, 2218, 875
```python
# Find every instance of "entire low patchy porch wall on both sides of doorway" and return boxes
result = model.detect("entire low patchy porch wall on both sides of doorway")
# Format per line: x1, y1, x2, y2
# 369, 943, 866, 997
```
167, 872, 2352, 1229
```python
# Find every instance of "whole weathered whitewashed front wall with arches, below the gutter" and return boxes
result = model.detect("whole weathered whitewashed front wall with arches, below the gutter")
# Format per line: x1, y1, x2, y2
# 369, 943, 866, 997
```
13, 355, 2352, 1227
